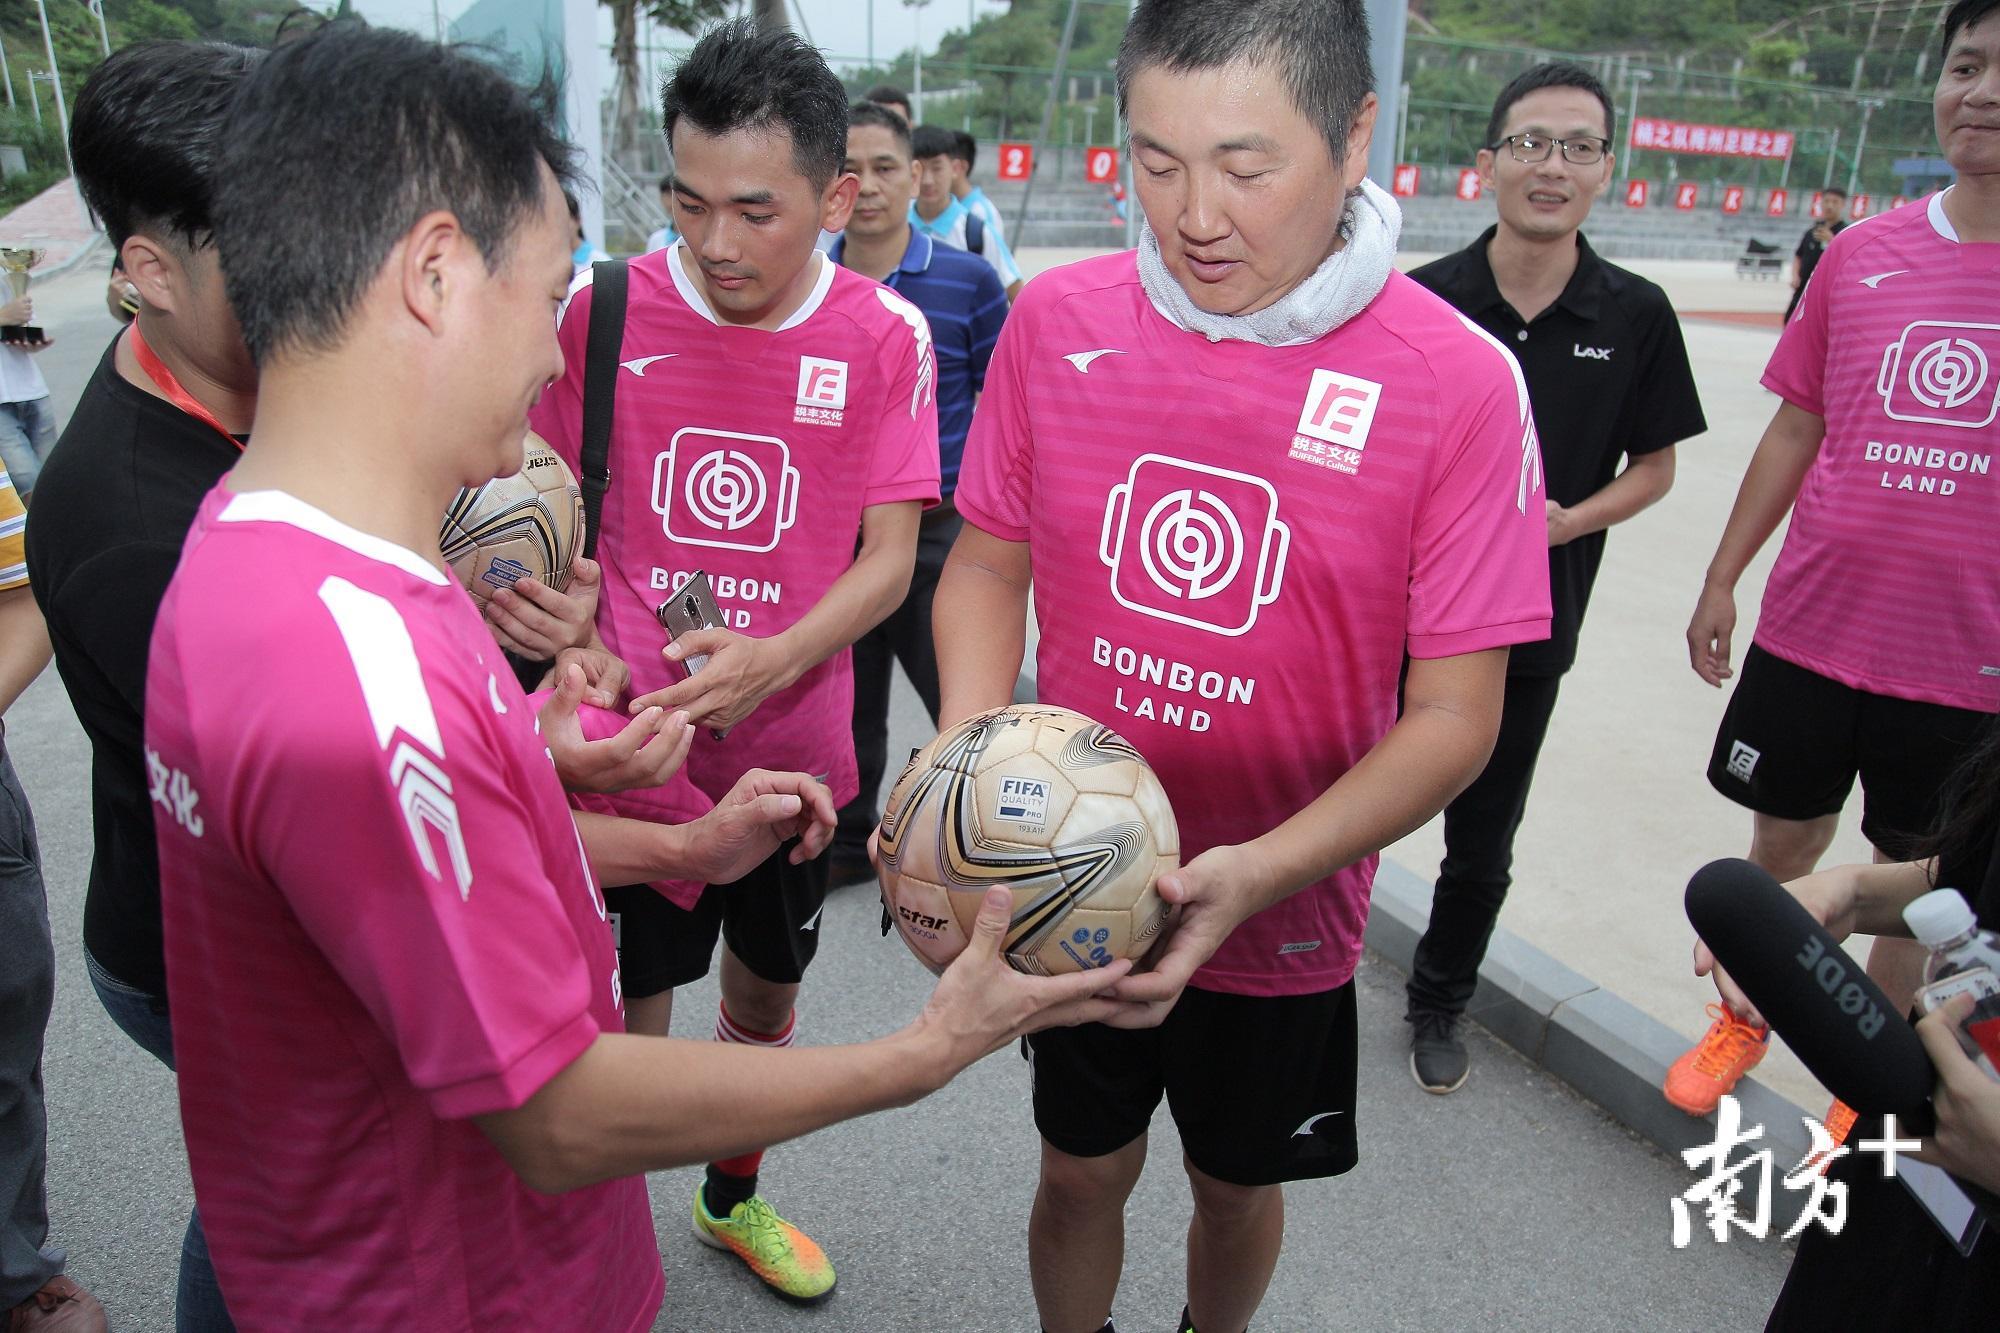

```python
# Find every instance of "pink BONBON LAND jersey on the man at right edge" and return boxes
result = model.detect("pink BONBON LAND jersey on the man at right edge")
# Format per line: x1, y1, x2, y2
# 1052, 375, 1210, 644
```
1756, 194, 2000, 713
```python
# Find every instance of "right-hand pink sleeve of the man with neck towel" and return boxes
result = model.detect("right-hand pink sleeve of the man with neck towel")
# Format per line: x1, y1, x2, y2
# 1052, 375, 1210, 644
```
1408, 344, 1550, 658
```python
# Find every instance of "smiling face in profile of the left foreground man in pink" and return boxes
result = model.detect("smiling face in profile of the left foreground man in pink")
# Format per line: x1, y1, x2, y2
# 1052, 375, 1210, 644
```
478, 166, 574, 486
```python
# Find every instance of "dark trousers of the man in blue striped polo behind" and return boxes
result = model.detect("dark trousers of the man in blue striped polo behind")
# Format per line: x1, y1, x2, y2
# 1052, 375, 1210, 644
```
834, 514, 964, 857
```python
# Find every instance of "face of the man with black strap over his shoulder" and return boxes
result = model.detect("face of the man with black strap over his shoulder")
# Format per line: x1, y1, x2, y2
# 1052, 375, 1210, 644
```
674, 122, 854, 324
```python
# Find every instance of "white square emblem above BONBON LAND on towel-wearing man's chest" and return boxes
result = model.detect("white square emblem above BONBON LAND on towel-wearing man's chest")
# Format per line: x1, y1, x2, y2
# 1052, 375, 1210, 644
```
1098, 454, 1292, 636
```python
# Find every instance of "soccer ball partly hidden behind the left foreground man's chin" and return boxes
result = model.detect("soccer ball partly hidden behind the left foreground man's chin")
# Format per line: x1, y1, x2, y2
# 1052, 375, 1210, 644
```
438, 430, 584, 602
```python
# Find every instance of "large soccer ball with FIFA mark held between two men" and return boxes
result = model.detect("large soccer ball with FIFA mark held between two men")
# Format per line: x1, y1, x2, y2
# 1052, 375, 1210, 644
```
880, 705, 1180, 977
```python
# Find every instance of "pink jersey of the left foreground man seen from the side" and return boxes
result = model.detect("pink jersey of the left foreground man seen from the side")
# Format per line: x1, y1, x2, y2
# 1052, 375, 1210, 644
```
146, 484, 664, 1331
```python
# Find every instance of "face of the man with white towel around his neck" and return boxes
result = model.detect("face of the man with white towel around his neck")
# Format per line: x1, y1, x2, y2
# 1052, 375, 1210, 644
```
1128, 60, 1376, 314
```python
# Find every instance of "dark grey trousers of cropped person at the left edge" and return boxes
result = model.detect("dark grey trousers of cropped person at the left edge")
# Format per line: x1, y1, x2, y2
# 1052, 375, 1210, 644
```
0, 745, 64, 1313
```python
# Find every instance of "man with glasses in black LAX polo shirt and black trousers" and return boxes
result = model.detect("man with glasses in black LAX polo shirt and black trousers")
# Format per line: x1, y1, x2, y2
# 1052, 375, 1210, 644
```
1408, 62, 1708, 1095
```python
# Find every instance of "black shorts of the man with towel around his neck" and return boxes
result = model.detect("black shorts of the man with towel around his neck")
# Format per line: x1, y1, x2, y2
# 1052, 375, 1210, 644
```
1024, 981, 1358, 1185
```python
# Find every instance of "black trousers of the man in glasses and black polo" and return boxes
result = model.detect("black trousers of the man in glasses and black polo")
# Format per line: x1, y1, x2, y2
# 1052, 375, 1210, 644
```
1408, 677, 1562, 1015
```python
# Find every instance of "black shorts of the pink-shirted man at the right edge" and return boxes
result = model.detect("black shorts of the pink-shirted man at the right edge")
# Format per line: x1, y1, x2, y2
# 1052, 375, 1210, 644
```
1708, 644, 1992, 857
